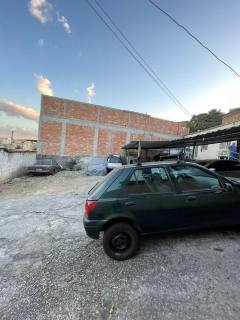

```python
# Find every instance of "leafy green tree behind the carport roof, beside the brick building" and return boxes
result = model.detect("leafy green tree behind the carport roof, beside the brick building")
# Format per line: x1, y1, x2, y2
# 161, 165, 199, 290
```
187, 109, 223, 133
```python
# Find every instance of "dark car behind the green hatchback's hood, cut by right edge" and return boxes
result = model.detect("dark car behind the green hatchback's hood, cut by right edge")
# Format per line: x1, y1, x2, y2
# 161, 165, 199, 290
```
197, 160, 240, 178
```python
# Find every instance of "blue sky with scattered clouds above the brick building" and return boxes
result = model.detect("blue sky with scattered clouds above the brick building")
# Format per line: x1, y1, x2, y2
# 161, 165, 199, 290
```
0, 0, 240, 138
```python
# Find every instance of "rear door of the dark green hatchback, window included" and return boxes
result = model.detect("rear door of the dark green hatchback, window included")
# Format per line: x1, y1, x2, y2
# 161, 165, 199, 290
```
125, 166, 188, 233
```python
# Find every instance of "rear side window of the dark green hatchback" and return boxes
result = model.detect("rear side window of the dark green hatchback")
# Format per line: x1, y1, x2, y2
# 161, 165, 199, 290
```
126, 167, 173, 193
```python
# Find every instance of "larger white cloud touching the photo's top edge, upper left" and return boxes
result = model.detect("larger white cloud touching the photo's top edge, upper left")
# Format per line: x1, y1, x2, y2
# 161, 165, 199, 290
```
29, 0, 52, 24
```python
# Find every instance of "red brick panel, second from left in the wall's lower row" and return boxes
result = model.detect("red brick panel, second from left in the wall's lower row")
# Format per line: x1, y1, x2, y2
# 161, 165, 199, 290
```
64, 124, 94, 156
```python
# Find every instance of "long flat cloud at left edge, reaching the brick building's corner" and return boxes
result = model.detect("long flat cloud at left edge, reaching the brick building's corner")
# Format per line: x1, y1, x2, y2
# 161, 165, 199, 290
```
0, 101, 39, 122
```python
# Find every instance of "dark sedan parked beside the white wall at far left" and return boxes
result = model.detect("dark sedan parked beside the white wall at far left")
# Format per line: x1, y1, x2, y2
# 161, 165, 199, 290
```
27, 159, 62, 175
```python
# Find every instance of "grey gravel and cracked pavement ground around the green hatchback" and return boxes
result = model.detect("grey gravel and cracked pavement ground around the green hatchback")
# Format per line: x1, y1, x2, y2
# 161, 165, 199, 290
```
0, 172, 240, 320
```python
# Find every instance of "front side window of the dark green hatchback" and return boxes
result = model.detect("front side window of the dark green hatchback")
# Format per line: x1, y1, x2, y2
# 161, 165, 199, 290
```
170, 166, 221, 192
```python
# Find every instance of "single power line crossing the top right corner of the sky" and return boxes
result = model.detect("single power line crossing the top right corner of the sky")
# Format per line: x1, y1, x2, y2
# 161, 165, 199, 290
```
148, 0, 240, 78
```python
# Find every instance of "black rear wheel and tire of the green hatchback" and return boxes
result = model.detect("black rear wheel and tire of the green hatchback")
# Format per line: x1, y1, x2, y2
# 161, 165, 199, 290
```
103, 223, 139, 260
